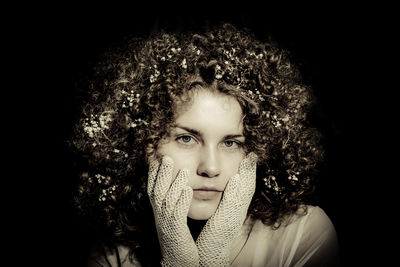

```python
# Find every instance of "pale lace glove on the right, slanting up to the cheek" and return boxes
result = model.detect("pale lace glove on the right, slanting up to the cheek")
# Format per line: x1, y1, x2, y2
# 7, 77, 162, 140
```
196, 153, 257, 266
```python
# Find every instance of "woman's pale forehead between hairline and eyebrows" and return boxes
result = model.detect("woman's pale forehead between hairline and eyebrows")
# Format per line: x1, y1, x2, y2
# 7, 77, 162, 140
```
175, 89, 243, 134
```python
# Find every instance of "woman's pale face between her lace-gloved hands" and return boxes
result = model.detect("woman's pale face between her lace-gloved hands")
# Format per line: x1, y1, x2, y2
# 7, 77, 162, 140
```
158, 89, 245, 220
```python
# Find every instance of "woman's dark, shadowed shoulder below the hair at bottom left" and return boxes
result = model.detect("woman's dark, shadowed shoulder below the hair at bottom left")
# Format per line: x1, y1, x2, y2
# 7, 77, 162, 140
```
87, 245, 141, 267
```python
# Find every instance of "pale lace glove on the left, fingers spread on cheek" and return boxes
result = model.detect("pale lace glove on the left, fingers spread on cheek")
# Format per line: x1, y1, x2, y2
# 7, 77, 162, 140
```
147, 156, 199, 267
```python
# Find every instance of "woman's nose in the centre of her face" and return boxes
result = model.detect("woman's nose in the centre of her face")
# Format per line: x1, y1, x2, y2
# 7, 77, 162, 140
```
197, 147, 221, 178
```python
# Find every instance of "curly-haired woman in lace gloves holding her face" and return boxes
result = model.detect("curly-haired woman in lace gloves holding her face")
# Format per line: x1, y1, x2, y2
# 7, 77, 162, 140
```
71, 24, 337, 266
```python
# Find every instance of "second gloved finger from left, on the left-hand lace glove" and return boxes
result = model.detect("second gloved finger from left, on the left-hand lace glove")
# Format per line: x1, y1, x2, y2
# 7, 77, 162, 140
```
154, 156, 174, 207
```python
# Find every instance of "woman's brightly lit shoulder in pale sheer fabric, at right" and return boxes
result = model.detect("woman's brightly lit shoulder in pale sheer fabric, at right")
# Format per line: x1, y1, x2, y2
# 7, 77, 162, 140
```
248, 206, 339, 266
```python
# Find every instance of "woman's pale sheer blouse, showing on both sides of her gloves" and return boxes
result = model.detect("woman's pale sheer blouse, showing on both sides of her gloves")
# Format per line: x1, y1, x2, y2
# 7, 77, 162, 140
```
88, 206, 339, 267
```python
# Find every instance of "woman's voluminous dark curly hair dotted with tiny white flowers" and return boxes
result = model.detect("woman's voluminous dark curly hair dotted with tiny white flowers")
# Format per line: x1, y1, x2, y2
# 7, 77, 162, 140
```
70, 23, 323, 264
